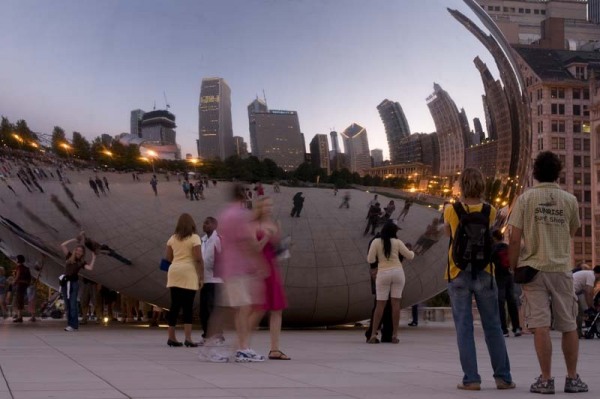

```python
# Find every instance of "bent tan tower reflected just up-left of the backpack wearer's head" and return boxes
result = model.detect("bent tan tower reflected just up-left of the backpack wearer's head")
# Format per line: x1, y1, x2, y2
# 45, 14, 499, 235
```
427, 83, 467, 177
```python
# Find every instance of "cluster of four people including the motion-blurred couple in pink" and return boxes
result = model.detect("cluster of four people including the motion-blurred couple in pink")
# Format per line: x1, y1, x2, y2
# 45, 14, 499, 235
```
165, 185, 290, 362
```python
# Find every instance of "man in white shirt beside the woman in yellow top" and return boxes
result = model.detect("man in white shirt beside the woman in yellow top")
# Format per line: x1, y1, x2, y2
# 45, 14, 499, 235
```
200, 216, 223, 338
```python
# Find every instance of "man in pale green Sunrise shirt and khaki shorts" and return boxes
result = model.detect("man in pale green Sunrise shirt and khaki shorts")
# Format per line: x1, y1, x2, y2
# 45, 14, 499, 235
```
508, 151, 588, 394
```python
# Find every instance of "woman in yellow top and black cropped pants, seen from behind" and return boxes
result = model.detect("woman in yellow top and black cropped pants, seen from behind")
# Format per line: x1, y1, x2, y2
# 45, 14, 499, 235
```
165, 213, 204, 348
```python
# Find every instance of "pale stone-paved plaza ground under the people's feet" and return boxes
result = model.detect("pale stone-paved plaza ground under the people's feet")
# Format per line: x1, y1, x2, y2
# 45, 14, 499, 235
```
0, 317, 600, 399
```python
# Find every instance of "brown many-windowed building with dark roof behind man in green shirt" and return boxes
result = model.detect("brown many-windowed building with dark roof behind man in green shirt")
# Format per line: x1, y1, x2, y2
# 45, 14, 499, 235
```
515, 47, 600, 264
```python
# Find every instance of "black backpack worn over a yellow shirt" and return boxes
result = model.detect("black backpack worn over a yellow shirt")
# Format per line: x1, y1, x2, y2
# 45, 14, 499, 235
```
448, 202, 492, 279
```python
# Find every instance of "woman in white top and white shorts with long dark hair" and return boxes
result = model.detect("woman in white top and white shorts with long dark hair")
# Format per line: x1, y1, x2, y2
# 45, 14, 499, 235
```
367, 223, 415, 344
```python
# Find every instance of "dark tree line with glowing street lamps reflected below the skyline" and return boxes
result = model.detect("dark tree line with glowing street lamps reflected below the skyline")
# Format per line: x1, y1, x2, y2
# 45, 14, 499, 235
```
0, 116, 410, 188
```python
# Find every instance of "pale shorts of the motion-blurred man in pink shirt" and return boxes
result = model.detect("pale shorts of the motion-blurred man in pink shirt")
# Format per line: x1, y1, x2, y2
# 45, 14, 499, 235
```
217, 276, 264, 307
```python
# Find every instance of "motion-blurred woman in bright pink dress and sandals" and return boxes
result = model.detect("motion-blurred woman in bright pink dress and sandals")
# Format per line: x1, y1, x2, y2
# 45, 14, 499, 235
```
255, 197, 290, 360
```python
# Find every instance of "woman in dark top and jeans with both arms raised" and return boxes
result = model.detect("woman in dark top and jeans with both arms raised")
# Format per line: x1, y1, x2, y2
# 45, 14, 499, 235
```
60, 238, 96, 331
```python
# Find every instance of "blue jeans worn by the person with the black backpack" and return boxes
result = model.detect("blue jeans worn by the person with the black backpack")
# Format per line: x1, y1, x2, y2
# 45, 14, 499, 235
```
448, 271, 512, 384
